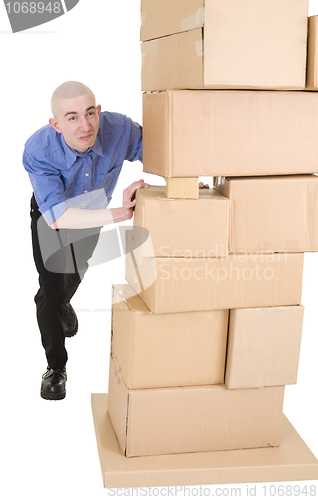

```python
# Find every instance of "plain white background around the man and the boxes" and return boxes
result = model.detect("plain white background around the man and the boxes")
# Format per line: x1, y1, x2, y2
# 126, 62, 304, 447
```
0, 0, 318, 500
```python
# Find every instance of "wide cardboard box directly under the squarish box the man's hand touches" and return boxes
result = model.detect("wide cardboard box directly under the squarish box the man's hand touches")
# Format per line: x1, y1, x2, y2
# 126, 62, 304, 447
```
125, 231, 304, 313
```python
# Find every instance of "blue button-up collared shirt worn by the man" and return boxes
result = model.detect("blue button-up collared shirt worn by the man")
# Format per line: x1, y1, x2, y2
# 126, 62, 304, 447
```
23, 111, 142, 224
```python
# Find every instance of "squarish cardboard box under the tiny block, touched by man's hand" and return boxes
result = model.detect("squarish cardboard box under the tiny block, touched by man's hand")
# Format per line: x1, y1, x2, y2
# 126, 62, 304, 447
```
134, 186, 230, 257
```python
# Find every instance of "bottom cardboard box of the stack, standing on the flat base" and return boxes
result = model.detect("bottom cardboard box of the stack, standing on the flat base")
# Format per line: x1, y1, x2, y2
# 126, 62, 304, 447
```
108, 359, 284, 457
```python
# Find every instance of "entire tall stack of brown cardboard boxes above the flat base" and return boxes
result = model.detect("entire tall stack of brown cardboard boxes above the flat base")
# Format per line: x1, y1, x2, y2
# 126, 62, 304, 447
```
92, 0, 318, 488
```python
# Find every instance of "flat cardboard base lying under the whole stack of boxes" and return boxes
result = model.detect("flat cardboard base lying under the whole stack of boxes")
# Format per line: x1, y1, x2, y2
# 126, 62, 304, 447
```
92, 394, 318, 486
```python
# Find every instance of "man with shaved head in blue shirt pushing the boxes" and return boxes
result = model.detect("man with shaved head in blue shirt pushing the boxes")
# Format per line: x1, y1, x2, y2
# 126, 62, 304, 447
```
23, 82, 149, 400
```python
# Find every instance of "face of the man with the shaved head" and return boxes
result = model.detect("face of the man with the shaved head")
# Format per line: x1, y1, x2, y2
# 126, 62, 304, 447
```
49, 92, 101, 153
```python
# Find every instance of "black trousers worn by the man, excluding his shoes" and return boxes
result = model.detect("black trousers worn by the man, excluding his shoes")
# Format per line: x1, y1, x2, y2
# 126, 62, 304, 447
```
30, 195, 101, 370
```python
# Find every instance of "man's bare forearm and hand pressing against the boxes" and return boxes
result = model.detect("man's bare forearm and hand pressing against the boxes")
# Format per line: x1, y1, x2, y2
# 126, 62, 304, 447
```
50, 179, 149, 229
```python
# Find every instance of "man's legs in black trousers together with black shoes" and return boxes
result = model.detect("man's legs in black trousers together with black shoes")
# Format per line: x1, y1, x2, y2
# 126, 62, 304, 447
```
31, 196, 100, 399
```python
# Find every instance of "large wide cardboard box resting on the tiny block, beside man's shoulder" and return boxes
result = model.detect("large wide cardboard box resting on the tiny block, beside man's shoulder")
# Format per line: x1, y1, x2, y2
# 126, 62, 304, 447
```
143, 90, 318, 177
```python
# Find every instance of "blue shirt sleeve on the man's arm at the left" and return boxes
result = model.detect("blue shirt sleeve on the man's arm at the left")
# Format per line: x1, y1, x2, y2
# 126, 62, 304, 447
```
22, 149, 68, 225
